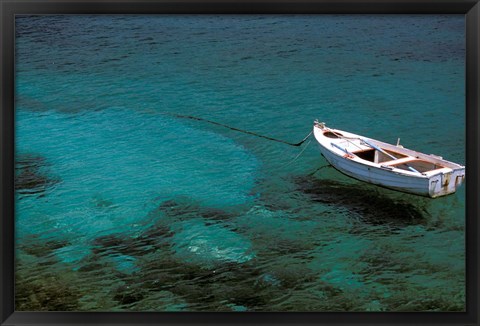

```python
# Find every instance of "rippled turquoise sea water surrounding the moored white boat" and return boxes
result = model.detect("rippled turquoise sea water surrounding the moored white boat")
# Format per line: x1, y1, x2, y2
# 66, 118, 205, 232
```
16, 15, 465, 311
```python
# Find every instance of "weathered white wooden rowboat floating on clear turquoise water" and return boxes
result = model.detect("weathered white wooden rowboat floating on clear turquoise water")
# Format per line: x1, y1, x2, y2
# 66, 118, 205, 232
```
313, 121, 465, 198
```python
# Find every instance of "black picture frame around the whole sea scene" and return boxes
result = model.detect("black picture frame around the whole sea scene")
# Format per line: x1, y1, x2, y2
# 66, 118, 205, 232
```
0, 0, 480, 325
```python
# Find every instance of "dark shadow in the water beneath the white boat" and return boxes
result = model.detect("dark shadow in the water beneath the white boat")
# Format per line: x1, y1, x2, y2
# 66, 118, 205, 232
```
296, 178, 428, 227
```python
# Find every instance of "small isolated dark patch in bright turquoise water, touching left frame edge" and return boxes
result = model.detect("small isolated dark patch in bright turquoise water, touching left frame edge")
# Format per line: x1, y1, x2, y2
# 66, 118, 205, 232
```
15, 154, 59, 195
